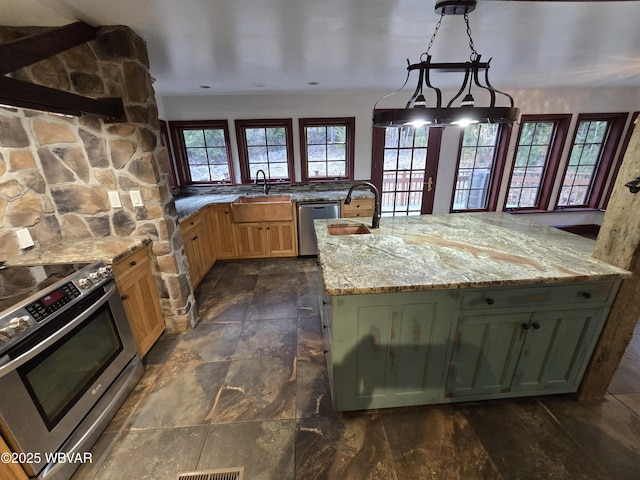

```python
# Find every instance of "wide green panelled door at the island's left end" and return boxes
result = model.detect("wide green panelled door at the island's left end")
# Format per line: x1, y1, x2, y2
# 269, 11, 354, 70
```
330, 292, 454, 410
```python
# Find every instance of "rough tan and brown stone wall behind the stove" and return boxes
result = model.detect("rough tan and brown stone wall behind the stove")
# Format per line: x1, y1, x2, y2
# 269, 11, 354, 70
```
0, 26, 196, 331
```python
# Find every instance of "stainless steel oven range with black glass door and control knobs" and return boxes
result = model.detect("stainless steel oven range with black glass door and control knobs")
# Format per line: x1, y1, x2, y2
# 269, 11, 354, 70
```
0, 263, 143, 480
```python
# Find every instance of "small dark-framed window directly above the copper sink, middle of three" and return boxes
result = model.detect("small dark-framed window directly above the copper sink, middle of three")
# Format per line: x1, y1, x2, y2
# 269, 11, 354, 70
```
235, 119, 295, 183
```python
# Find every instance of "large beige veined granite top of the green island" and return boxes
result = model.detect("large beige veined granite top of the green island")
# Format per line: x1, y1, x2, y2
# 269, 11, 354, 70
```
315, 213, 631, 295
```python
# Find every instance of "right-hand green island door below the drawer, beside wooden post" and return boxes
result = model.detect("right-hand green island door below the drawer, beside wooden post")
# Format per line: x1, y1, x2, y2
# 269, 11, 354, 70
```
511, 309, 604, 393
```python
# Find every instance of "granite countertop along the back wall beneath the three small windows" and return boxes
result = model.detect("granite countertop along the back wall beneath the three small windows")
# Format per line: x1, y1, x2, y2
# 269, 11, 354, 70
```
175, 188, 373, 221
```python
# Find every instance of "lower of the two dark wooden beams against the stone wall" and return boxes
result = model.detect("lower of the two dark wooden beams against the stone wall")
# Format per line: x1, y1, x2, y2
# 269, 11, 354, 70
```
0, 77, 125, 120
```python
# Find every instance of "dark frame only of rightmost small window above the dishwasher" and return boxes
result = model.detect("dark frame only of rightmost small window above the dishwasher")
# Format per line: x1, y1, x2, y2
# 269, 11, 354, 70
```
298, 117, 356, 183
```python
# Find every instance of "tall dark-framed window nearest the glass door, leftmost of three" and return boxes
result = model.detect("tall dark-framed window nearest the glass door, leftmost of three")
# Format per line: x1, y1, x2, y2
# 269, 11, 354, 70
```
451, 123, 510, 212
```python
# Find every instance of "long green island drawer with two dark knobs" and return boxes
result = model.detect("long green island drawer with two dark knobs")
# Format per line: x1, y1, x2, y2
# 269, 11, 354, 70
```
461, 281, 616, 310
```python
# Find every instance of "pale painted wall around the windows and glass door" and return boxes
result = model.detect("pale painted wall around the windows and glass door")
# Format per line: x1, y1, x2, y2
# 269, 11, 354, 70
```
158, 86, 640, 225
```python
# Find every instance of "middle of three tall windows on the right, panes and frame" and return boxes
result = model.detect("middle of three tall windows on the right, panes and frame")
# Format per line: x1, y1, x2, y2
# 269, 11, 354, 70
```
505, 114, 571, 211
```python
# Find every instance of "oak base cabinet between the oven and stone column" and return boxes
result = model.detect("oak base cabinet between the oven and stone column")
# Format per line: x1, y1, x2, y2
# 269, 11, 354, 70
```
113, 248, 165, 357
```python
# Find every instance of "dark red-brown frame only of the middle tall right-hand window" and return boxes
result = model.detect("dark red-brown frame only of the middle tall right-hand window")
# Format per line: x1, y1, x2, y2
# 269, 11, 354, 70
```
502, 113, 572, 213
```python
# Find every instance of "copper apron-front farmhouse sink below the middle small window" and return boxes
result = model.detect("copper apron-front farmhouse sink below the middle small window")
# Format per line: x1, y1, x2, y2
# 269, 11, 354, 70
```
231, 195, 293, 223
